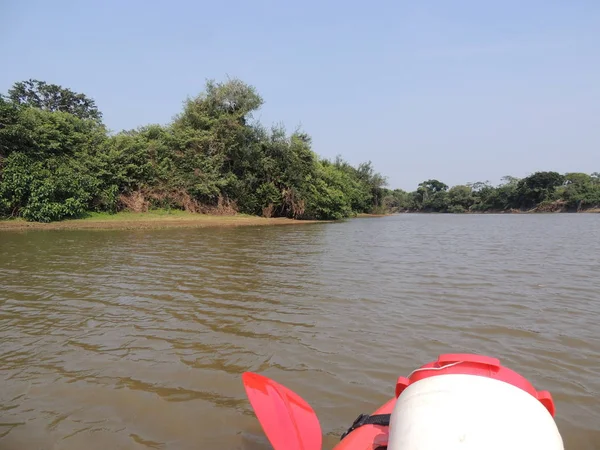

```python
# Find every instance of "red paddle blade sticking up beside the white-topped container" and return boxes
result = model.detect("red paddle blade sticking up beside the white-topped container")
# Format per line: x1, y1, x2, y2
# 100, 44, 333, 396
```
242, 372, 323, 450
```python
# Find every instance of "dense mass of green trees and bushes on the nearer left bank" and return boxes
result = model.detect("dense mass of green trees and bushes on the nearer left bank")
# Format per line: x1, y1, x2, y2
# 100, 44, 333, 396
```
0, 79, 391, 222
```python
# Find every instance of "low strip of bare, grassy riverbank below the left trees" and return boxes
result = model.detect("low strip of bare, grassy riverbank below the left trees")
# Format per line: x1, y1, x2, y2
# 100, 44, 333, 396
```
0, 211, 324, 231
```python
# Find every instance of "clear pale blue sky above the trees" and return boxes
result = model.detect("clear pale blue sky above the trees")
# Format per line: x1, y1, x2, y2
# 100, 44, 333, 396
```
0, 0, 600, 190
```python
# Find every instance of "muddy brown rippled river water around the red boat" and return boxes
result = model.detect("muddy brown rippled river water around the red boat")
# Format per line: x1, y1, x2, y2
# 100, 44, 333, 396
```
0, 214, 600, 450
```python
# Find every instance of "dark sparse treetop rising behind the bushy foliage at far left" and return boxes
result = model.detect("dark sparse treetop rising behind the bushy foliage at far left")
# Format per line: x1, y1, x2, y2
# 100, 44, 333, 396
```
8, 79, 102, 122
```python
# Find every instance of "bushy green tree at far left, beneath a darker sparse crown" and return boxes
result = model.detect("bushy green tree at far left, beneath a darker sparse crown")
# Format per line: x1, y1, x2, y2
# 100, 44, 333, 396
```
0, 108, 105, 222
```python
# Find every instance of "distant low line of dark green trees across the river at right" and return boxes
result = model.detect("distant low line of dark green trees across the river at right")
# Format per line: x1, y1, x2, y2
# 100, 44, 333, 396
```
383, 172, 600, 213
